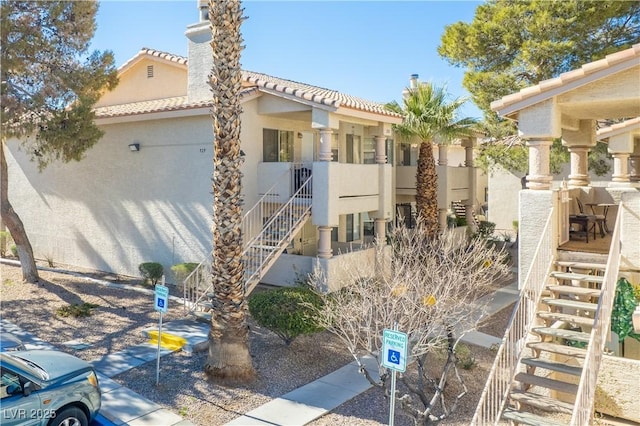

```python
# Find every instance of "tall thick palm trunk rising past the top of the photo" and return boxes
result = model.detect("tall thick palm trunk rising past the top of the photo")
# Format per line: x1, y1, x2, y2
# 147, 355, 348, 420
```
204, 0, 255, 381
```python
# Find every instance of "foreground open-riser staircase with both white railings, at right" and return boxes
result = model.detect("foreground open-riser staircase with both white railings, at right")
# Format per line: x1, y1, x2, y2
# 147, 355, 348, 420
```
471, 205, 622, 426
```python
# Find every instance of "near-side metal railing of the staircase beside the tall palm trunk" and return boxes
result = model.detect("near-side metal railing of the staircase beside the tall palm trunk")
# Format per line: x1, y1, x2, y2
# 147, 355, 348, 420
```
243, 176, 312, 293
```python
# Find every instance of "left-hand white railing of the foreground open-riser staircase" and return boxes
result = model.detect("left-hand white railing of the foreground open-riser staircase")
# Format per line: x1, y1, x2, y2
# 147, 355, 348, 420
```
471, 209, 555, 426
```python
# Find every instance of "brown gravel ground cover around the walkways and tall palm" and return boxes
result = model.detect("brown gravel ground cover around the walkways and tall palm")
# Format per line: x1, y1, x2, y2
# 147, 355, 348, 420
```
0, 264, 510, 426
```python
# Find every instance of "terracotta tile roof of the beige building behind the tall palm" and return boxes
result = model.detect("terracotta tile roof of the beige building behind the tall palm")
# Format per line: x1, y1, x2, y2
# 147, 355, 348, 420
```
96, 47, 400, 118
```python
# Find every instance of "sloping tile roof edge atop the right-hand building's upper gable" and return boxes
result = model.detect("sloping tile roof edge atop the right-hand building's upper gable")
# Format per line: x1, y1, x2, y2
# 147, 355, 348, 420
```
491, 44, 640, 115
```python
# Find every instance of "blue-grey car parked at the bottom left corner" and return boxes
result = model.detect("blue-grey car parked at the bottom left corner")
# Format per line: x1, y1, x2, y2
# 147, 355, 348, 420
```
0, 350, 101, 426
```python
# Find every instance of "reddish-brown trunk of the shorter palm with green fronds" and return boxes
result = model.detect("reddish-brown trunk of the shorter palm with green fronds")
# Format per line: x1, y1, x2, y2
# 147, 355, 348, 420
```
416, 141, 438, 237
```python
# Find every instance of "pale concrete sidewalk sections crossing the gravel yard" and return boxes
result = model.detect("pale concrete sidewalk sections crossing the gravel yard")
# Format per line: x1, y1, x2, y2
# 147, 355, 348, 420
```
0, 260, 518, 426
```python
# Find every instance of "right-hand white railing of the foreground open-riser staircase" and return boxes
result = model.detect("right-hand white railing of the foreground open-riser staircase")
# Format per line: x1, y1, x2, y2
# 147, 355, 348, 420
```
571, 203, 623, 426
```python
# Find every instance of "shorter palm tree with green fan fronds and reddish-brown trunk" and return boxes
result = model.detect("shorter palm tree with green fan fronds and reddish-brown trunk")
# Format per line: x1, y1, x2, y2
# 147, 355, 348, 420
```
387, 83, 476, 236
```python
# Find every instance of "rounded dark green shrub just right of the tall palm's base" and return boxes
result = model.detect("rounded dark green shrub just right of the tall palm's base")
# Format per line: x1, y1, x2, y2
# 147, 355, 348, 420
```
249, 287, 322, 346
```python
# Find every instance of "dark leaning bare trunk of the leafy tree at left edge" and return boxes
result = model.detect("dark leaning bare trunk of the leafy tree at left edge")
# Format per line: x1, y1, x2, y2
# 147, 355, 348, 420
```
0, 140, 40, 283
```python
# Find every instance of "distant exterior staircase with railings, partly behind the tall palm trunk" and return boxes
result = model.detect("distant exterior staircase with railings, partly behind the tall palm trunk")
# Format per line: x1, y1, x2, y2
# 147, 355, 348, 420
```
183, 166, 312, 322
